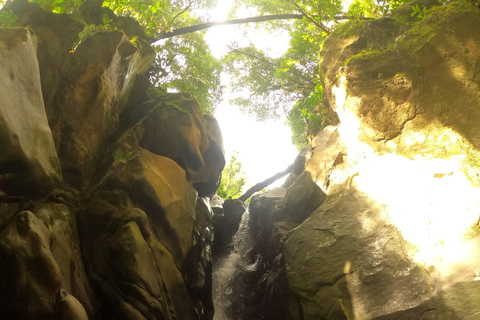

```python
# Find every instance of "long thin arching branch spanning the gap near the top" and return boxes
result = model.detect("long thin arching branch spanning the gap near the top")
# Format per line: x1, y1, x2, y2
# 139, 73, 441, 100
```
150, 14, 304, 42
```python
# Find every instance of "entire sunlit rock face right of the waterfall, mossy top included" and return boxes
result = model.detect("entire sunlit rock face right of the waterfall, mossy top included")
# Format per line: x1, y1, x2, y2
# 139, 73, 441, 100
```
238, 3, 480, 320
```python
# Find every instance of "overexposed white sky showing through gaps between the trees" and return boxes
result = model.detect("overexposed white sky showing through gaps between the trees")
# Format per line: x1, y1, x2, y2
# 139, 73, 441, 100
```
200, 0, 298, 187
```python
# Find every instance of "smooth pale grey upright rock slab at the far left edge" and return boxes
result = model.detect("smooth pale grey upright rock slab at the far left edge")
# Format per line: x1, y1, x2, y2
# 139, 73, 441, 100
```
0, 28, 62, 196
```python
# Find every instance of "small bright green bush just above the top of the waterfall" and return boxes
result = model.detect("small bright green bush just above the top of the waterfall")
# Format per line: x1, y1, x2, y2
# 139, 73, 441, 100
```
217, 152, 245, 200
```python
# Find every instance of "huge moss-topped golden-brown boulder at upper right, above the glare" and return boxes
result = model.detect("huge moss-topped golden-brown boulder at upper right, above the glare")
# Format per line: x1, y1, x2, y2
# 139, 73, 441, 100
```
322, 3, 480, 160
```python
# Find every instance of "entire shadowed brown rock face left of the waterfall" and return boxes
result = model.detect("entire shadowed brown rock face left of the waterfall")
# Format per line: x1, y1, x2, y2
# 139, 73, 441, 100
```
0, 3, 225, 320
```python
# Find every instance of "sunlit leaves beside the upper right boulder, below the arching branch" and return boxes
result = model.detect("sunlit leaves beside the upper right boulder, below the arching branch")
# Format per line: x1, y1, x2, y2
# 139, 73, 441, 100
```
223, 11, 327, 148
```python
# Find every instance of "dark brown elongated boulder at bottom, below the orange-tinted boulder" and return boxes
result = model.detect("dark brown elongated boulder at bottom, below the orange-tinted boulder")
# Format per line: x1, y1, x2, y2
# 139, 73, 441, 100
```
81, 195, 195, 319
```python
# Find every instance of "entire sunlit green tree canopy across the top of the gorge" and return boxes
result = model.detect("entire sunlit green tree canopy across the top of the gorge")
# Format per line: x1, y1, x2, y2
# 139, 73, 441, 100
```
0, 0, 430, 147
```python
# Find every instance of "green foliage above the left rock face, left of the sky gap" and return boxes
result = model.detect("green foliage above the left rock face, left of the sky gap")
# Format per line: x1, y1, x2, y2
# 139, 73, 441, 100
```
23, 0, 222, 114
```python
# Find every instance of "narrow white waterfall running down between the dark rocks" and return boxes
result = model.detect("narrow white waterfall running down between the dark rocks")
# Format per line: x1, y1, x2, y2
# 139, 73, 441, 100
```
213, 210, 254, 320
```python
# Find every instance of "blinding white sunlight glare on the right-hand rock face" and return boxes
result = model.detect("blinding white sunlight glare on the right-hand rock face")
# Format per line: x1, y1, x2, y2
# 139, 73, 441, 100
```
333, 71, 480, 272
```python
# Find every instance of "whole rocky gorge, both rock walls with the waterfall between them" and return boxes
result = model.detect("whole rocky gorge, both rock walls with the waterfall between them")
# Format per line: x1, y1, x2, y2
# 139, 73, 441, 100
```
0, 1, 480, 320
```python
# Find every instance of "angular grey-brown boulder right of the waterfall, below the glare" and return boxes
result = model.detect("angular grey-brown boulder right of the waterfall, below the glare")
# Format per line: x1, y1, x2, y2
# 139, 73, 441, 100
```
284, 181, 433, 320
